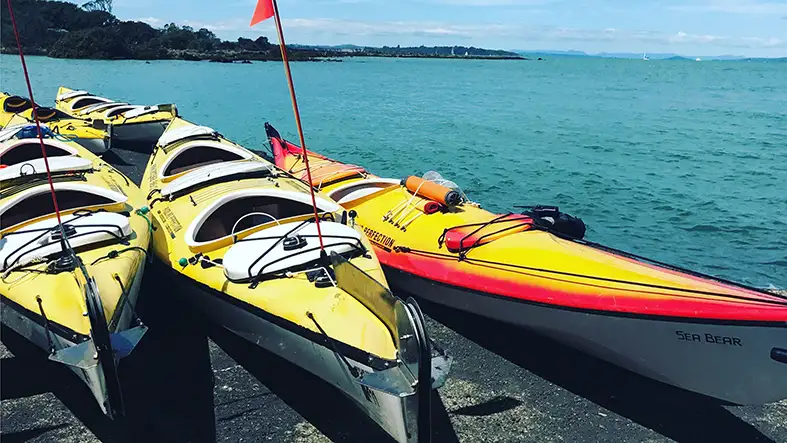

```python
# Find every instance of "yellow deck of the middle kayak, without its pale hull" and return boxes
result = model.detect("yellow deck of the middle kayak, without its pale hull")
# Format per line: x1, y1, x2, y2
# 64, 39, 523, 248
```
142, 119, 396, 360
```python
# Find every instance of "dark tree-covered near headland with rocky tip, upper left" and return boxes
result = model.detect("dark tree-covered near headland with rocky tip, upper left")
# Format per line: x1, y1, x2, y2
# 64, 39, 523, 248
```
0, 0, 321, 61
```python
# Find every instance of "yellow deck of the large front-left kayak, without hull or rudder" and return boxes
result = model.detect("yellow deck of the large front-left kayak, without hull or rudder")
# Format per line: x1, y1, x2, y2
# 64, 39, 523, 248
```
0, 139, 150, 339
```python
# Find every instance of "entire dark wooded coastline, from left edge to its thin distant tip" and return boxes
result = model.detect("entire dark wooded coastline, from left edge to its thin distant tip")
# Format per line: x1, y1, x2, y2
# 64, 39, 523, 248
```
0, 0, 526, 63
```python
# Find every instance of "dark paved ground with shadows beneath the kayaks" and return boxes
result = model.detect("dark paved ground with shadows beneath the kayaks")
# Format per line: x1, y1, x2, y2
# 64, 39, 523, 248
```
0, 147, 787, 443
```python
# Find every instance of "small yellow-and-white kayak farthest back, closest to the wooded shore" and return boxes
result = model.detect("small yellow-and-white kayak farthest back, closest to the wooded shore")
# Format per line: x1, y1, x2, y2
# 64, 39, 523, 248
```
55, 86, 178, 145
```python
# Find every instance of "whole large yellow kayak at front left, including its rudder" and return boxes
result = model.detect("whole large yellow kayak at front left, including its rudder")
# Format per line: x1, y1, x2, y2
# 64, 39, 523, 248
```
0, 134, 151, 418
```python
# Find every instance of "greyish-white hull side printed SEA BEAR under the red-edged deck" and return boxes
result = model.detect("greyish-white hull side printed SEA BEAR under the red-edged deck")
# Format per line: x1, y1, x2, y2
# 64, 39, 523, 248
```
383, 266, 787, 404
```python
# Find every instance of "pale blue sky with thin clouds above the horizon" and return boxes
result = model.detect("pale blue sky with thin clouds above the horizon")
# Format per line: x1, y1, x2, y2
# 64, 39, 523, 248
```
106, 0, 787, 57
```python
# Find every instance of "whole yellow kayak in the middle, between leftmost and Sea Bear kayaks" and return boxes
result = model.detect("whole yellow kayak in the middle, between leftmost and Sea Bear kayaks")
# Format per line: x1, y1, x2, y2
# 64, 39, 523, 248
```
142, 118, 447, 443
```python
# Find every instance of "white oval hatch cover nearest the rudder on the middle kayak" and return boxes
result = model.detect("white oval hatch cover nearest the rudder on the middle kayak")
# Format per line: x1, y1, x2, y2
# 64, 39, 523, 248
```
223, 222, 361, 281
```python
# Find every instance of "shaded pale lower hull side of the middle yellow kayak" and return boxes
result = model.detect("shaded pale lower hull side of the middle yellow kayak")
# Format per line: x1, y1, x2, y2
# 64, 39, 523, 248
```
178, 277, 422, 443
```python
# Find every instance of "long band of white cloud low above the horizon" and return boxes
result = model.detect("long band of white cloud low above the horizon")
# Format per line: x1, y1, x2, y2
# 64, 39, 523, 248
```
144, 18, 787, 51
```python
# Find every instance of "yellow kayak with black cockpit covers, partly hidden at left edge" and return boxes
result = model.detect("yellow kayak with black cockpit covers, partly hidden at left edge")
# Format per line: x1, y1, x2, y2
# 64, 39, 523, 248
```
0, 92, 111, 155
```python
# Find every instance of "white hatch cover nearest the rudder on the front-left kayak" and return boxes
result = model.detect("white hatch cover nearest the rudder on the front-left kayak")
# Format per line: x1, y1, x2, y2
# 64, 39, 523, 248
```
0, 212, 131, 271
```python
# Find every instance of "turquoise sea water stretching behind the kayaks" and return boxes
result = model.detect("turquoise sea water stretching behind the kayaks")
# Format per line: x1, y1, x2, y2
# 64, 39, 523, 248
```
0, 56, 787, 288
